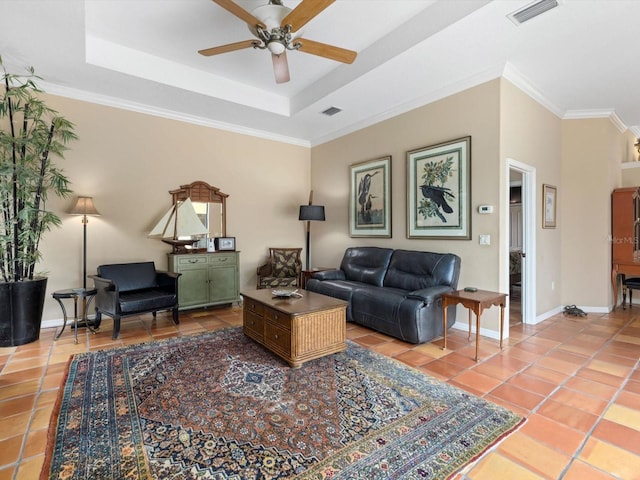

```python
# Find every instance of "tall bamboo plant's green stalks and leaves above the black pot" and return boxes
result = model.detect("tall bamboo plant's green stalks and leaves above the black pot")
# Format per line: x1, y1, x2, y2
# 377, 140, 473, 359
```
0, 57, 77, 282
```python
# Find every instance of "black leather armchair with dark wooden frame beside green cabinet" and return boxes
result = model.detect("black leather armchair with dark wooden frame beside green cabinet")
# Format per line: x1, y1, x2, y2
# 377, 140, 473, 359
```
91, 262, 181, 340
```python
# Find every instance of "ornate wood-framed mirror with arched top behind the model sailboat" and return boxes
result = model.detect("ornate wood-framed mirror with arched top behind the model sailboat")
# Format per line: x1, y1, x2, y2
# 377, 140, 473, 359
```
169, 181, 229, 248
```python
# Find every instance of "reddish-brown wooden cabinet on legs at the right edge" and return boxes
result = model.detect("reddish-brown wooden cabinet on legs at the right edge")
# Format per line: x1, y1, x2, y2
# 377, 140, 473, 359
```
611, 187, 640, 310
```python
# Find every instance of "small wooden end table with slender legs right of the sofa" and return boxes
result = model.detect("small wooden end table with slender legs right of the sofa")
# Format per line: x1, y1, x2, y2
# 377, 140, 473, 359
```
442, 290, 507, 362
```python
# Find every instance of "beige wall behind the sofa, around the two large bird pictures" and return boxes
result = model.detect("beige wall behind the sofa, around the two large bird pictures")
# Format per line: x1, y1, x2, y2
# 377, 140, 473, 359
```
311, 80, 501, 330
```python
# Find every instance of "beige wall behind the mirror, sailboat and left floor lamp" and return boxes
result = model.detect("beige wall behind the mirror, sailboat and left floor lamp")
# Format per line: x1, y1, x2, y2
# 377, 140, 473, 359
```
38, 96, 310, 321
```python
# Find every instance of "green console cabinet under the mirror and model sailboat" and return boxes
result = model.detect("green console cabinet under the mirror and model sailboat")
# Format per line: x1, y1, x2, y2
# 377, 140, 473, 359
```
169, 252, 240, 310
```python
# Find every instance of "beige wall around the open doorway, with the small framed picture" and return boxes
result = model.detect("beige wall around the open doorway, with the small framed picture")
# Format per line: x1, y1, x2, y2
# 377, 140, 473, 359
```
500, 80, 564, 315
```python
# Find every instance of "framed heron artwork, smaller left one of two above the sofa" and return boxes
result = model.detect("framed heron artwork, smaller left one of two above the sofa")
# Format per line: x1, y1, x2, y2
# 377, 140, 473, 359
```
349, 156, 391, 237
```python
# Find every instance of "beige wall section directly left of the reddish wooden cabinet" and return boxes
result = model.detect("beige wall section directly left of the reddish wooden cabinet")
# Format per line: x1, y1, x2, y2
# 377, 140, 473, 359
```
559, 118, 624, 308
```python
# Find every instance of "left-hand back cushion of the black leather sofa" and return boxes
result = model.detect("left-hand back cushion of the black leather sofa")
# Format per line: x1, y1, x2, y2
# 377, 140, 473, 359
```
340, 247, 393, 287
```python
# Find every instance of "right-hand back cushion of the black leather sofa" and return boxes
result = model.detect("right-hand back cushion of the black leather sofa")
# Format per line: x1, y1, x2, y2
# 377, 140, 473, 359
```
384, 250, 460, 291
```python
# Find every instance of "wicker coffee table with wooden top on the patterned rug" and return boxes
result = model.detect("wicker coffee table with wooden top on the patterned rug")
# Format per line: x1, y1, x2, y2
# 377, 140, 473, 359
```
241, 290, 347, 368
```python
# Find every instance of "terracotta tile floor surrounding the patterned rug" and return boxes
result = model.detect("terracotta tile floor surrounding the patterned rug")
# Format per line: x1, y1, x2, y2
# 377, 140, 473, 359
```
0, 307, 640, 480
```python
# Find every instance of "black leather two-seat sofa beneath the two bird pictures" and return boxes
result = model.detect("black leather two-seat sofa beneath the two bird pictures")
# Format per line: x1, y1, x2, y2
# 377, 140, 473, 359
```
305, 247, 460, 343
